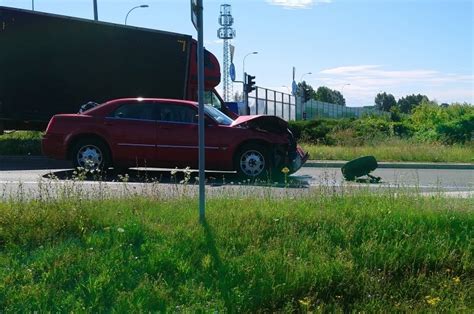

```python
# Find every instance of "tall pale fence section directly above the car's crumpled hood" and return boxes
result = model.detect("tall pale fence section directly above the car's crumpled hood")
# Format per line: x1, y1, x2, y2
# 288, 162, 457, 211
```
248, 87, 296, 121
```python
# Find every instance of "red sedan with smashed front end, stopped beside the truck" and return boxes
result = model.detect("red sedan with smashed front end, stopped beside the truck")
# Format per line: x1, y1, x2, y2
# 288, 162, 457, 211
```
42, 98, 308, 178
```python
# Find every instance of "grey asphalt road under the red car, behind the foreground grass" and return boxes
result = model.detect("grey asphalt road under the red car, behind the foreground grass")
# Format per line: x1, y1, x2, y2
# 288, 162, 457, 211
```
0, 157, 474, 199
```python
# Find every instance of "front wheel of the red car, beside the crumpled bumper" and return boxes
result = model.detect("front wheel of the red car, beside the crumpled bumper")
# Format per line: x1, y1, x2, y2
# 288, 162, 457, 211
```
234, 144, 269, 179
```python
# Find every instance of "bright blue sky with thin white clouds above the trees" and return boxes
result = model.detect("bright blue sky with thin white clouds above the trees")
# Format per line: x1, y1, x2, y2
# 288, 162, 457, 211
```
0, 0, 474, 106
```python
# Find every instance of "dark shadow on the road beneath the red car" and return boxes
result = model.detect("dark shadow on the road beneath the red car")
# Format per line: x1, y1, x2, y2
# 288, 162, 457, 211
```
43, 169, 309, 188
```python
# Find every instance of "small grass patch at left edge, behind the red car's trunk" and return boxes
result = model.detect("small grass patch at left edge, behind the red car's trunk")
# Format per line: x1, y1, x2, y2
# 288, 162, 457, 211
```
0, 131, 42, 155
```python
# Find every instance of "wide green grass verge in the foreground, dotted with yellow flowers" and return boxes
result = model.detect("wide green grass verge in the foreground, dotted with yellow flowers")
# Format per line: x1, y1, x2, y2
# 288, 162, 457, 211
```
0, 191, 474, 312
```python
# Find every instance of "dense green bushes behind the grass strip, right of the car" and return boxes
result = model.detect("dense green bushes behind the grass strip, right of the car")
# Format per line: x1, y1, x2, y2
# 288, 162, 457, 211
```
290, 100, 474, 146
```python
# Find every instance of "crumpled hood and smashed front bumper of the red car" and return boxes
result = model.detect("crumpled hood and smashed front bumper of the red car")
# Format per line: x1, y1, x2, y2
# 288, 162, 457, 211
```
232, 115, 309, 174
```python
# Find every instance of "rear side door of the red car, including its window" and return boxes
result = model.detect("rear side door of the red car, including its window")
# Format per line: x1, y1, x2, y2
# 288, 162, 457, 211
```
104, 102, 157, 167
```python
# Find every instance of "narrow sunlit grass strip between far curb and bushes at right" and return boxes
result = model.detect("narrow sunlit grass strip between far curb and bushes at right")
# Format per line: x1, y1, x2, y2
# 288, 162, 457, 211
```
302, 139, 474, 163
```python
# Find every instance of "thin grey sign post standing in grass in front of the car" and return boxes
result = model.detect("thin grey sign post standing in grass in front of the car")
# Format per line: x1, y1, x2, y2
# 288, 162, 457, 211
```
191, 0, 206, 223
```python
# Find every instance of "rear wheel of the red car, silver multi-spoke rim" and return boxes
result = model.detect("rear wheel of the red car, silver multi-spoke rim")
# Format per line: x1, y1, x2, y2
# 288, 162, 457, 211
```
72, 138, 110, 171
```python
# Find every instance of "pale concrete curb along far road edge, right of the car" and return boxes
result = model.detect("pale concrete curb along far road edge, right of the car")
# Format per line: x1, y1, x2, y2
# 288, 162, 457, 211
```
303, 160, 474, 170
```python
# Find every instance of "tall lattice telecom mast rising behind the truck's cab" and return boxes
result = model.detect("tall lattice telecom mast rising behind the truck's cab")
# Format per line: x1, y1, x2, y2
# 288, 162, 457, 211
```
217, 4, 235, 101
